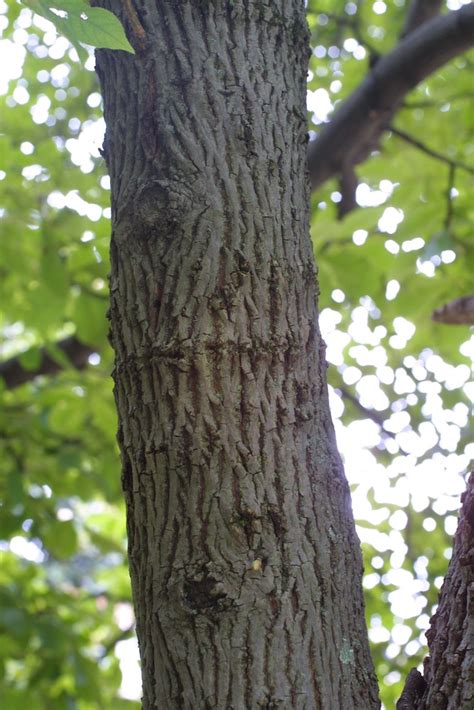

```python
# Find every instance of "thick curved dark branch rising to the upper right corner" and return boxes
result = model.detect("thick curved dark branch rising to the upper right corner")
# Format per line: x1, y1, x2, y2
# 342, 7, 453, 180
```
308, 4, 474, 206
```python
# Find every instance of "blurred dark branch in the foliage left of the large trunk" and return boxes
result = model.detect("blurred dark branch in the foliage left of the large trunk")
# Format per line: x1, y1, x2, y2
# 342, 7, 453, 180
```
0, 336, 95, 389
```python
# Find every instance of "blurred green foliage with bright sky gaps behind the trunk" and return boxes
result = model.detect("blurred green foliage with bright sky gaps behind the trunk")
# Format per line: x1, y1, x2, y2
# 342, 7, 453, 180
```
0, 0, 474, 710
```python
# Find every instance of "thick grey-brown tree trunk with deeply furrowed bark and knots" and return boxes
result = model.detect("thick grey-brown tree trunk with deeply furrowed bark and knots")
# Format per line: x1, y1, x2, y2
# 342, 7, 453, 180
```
97, 0, 379, 710
